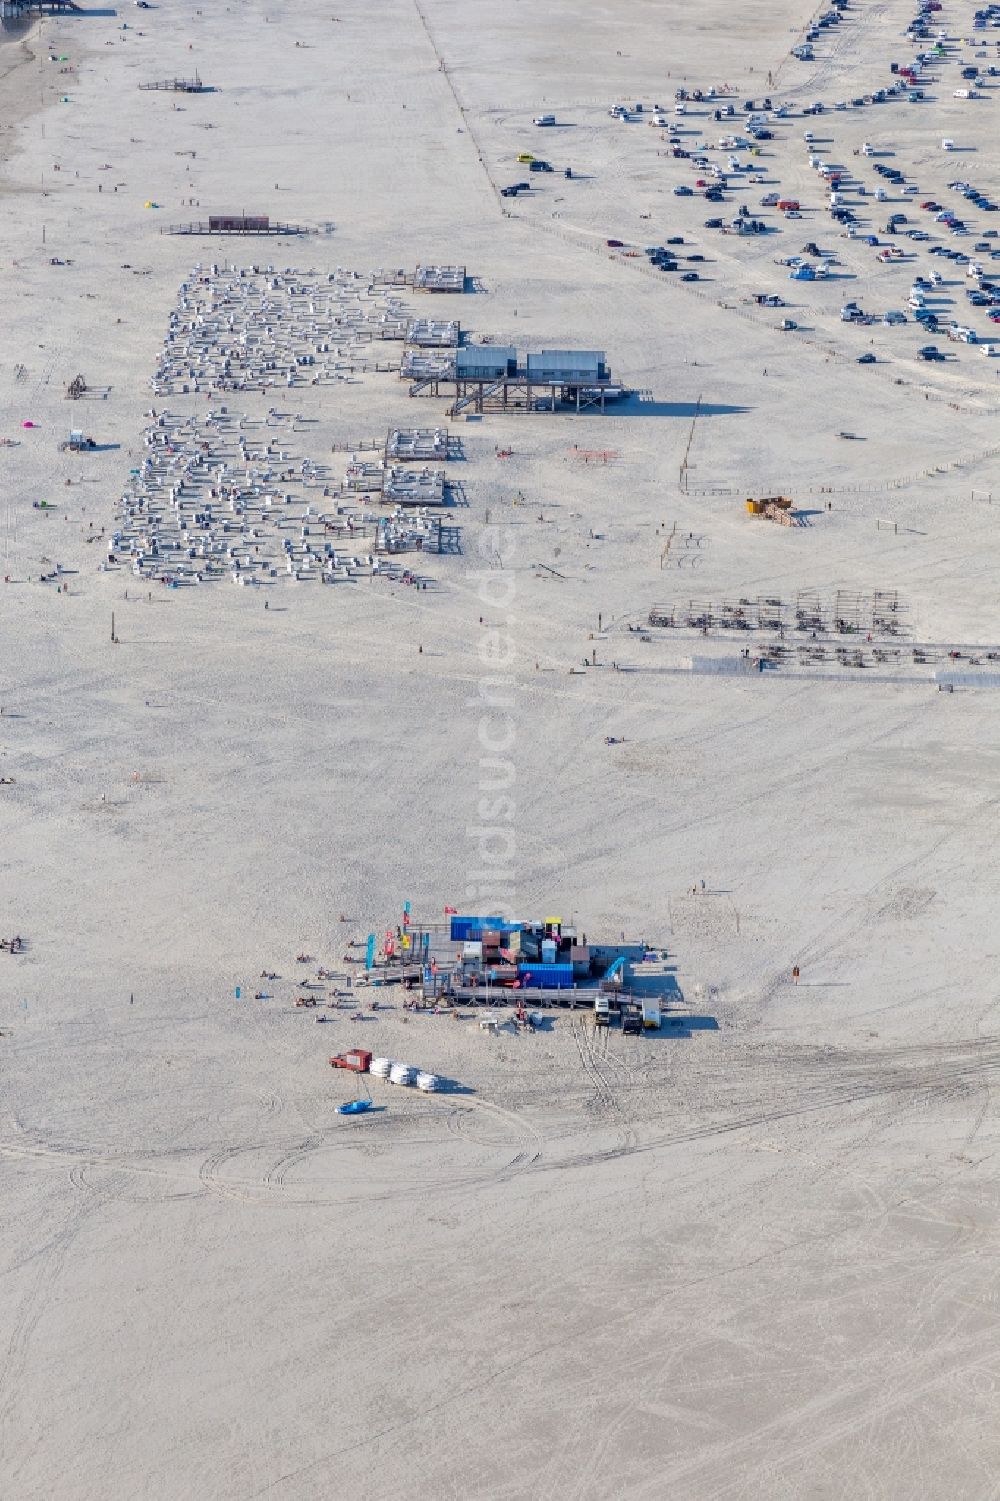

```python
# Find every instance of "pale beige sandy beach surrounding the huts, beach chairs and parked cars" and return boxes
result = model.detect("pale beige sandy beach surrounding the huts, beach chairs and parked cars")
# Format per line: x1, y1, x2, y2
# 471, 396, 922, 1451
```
0, 0, 1000, 1501
